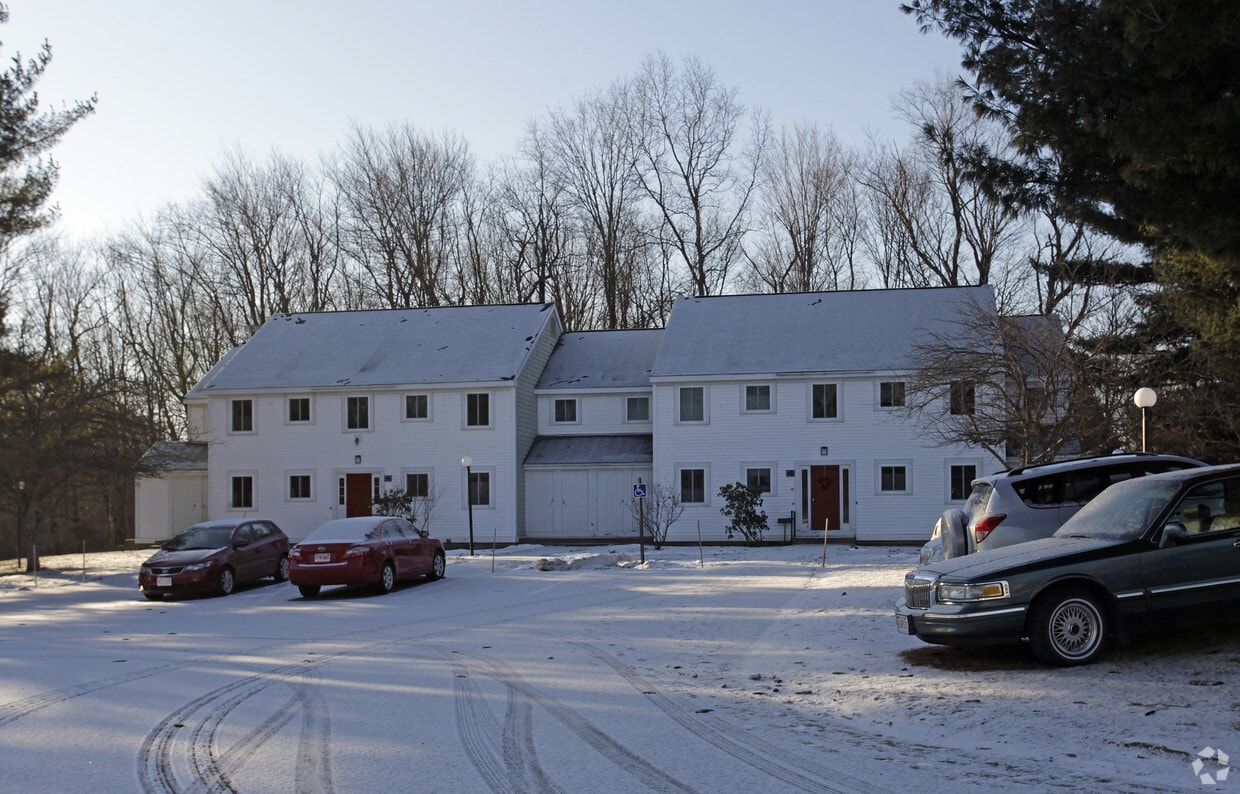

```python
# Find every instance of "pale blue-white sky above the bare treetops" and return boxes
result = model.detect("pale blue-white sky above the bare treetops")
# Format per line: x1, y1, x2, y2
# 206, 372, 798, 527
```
0, 0, 960, 237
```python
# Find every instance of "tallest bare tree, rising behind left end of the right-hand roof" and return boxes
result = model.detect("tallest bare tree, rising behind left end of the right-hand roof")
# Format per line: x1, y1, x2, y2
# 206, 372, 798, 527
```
632, 53, 769, 295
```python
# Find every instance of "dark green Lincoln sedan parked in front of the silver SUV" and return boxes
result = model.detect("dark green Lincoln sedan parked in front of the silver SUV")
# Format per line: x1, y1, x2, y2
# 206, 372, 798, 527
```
895, 464, 1240, 665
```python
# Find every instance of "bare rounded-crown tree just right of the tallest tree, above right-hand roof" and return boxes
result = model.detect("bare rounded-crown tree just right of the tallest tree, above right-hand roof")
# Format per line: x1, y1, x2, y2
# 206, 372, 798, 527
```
743, 125, 864, 293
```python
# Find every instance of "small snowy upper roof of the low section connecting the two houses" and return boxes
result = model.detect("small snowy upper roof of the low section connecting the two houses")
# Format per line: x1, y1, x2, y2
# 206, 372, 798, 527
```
538, 330, 663, 390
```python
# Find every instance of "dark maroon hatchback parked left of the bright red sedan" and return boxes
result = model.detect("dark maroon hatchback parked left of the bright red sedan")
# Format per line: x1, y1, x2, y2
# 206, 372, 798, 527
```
138, 519, 289, 600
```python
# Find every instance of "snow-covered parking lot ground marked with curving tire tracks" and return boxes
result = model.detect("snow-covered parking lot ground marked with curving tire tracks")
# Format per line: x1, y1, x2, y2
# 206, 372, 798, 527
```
0, 546, 1240, 793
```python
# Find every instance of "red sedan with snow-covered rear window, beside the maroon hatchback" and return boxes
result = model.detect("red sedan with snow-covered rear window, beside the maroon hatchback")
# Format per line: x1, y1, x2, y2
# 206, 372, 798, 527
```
289, 516, 446, 598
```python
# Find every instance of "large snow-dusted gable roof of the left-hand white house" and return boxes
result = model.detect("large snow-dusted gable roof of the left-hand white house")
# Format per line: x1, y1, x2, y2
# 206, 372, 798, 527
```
186, 304, 559, 399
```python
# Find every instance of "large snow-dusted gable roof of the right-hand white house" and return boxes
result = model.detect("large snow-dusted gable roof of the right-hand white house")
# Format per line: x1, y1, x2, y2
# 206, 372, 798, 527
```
651, 287, 994, 377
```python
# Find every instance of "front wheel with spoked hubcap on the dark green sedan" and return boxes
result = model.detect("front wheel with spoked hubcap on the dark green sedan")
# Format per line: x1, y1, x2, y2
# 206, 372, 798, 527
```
1029, 588, 1107, 667
